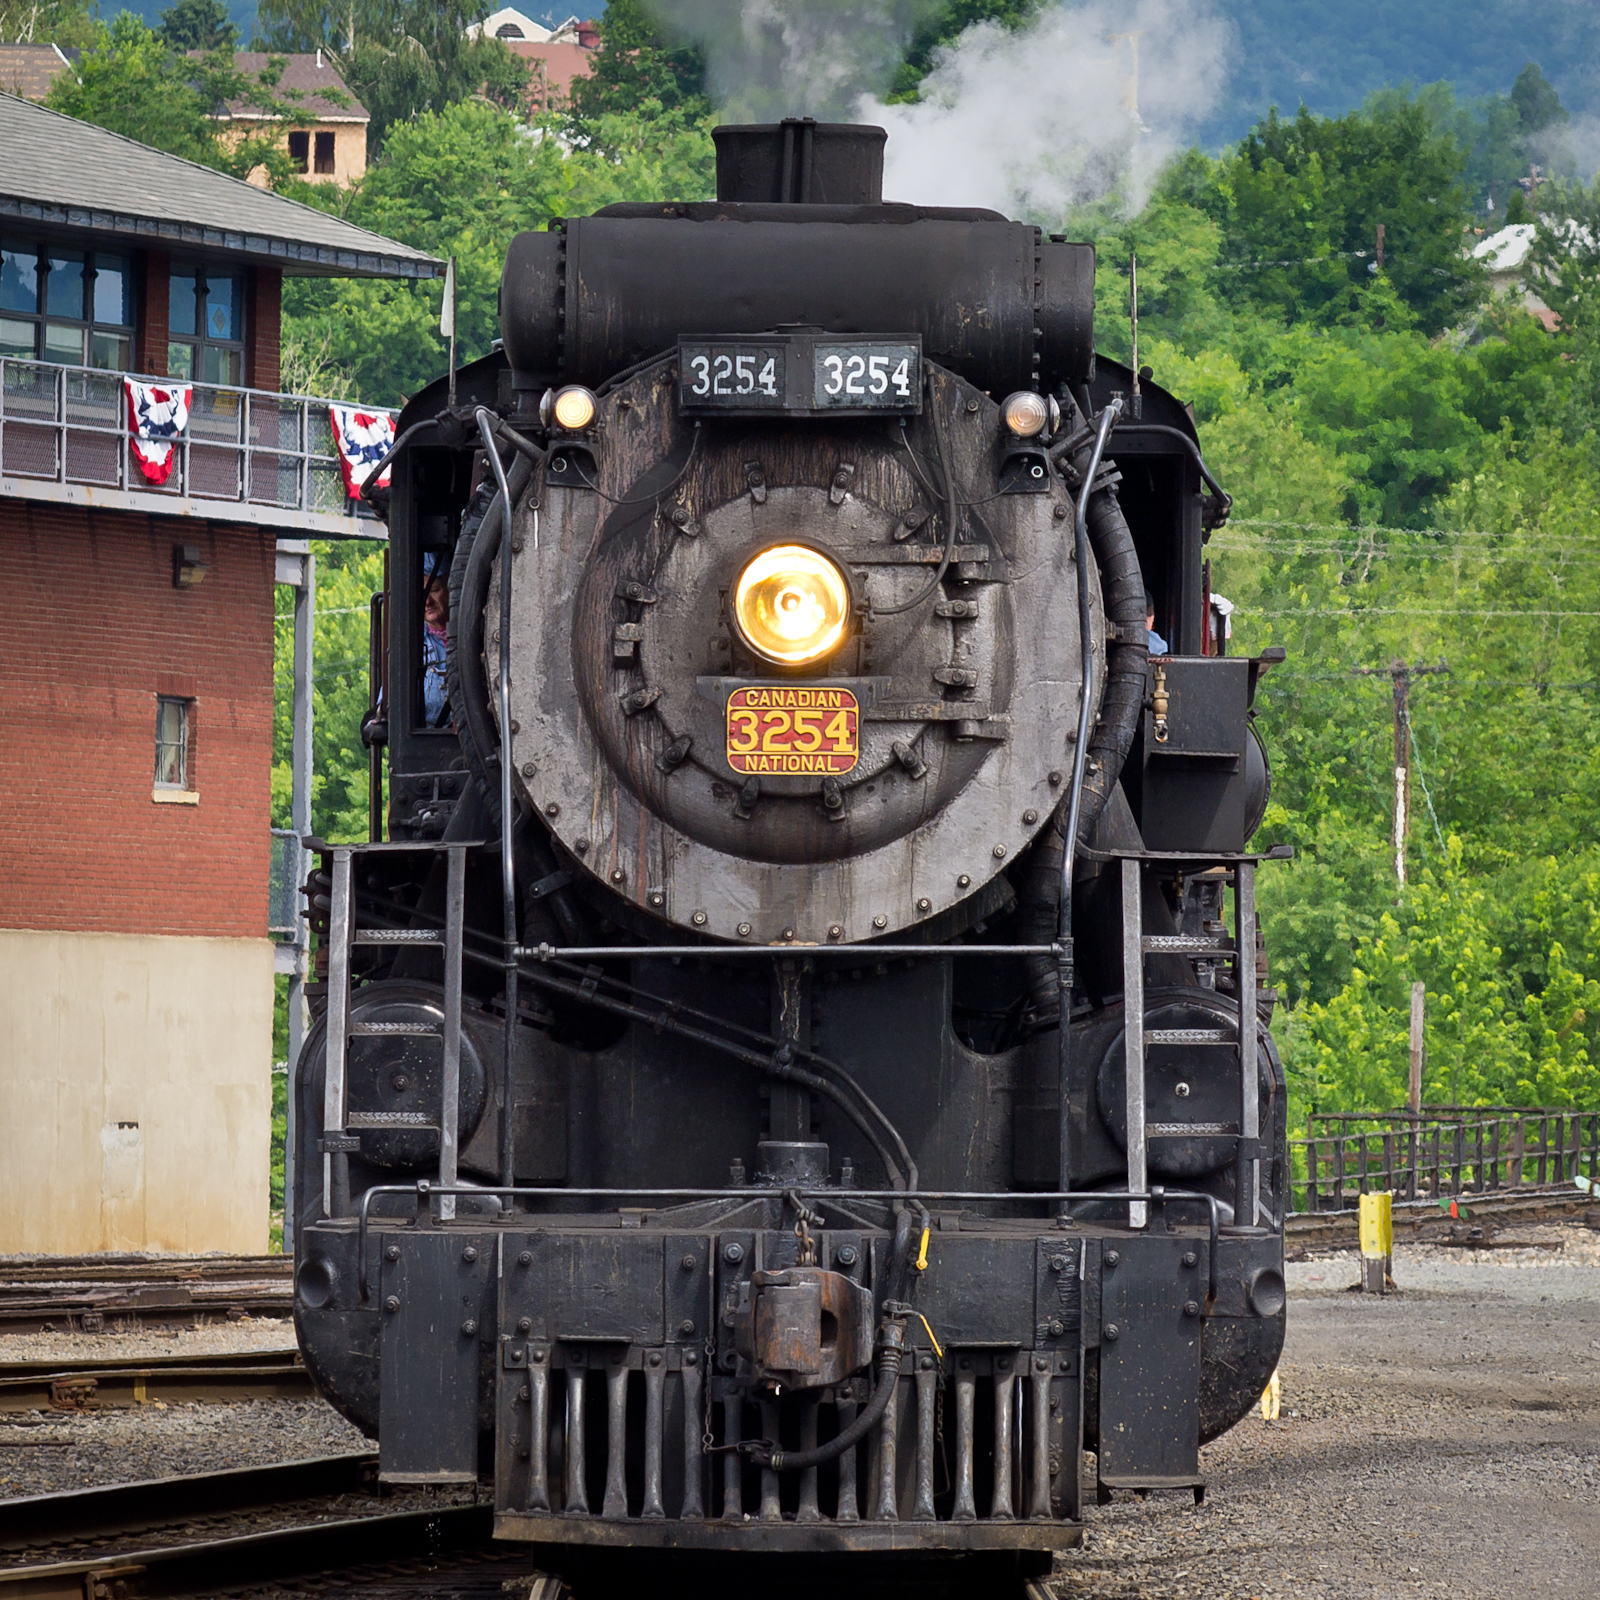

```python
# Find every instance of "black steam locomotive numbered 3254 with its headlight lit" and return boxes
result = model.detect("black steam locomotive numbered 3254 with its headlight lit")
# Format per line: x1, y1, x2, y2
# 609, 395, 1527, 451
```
294, 120, 1288, 1566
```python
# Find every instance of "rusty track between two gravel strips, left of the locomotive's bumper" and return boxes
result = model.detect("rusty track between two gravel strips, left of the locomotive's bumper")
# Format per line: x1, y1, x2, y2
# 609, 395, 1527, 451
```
0, 1346, 315, 1414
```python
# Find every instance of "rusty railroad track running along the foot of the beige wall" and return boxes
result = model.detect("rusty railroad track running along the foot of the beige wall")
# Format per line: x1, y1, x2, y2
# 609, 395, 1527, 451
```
0, 1256, 294, 1334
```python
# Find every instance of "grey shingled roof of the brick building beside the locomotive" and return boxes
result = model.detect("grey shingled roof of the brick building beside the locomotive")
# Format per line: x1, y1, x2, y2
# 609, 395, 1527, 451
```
0, 94, 445, 278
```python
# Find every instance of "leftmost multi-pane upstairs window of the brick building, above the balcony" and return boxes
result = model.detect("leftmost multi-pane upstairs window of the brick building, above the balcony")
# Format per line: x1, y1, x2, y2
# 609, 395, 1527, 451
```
0, 238, 133, 371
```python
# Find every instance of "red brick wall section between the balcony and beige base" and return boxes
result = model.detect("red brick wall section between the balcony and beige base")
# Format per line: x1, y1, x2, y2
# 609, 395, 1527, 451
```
0, 499, 274, 938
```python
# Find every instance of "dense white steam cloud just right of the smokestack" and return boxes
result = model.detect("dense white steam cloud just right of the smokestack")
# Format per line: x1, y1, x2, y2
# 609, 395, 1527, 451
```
856, 0, 1229, 221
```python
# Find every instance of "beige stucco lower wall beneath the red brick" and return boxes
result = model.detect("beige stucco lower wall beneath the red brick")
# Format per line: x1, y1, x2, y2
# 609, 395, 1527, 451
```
0, 928, 272, 1254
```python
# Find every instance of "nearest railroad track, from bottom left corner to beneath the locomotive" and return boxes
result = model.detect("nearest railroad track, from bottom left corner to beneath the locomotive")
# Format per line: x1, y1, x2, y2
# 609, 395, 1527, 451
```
0, 1453, 1050, 1600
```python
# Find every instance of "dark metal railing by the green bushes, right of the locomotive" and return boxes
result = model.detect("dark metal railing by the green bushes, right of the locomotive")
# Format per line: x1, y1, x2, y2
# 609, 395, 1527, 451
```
1290, 1106, 1600, 1216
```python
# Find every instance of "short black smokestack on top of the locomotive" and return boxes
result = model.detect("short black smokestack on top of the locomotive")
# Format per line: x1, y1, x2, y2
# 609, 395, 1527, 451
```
710, 117, 888, 205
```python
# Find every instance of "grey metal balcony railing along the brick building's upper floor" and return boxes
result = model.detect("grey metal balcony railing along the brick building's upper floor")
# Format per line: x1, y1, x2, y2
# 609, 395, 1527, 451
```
0, 357, 390, 538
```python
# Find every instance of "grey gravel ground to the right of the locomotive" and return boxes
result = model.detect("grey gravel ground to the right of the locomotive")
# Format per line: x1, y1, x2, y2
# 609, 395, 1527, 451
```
1054, 1226, 1600, 1600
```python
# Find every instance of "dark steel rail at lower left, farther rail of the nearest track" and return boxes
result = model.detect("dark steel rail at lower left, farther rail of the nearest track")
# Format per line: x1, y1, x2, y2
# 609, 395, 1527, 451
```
0, 1451, 378, 1552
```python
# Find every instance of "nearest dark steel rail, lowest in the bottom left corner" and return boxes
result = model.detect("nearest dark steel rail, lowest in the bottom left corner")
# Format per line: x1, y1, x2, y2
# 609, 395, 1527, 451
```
0, 1506, 494, 1600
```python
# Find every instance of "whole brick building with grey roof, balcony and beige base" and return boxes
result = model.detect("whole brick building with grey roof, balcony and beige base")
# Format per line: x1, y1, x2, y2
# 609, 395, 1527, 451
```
0, 94, 440, 1253
